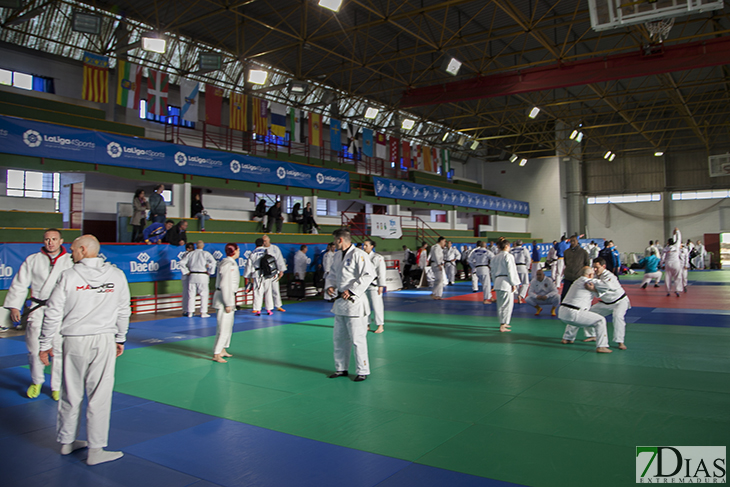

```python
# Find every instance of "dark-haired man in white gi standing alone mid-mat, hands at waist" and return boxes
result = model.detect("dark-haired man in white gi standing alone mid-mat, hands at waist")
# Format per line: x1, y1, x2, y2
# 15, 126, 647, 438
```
325, 228, 375, 382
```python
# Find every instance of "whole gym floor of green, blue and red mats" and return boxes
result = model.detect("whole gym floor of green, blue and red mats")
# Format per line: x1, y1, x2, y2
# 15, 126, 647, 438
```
0, 271, 730, 487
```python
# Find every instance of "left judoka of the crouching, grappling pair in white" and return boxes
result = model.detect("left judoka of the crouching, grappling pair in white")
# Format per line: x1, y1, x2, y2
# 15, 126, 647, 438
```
558, 267, 612, 353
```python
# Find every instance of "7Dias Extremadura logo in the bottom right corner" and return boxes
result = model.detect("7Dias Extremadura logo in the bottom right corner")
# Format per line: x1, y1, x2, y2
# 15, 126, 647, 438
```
636, 446, 727, 484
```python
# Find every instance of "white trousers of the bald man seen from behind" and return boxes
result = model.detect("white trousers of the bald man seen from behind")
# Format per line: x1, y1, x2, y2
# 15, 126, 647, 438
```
56, 333, 117, 448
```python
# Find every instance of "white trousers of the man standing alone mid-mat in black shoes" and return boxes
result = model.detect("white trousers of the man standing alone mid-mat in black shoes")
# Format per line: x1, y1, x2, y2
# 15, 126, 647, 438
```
332, 315, 370, 375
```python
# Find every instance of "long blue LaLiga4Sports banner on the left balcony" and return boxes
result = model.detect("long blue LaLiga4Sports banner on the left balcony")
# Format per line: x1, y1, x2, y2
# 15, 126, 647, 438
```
0, 116, 350, 193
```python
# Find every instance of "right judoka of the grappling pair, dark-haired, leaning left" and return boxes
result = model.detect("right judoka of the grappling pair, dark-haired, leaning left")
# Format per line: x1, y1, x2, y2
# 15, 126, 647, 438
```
585, 257, 631, 350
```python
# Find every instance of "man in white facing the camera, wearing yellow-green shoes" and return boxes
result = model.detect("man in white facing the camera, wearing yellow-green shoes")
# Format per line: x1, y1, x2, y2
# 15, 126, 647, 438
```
4, 228, 73, 401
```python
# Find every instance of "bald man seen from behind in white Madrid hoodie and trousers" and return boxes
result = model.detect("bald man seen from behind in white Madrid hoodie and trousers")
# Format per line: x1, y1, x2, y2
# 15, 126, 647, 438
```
39, 235, 131, 465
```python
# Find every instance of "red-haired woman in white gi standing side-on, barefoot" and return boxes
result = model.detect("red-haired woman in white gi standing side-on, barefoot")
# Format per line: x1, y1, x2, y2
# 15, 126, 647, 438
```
213, 243, 241, 364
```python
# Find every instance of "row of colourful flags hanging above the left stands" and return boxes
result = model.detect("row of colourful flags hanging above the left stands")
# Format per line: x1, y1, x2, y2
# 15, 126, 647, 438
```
78, 52, 444, 174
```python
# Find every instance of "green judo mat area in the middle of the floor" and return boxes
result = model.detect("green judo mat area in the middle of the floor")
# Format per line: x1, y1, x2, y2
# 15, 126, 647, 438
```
116, 312, 730, 487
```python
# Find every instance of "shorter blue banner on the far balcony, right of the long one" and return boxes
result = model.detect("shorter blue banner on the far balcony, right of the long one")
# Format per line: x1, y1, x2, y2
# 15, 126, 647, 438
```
373, 176, 530, 215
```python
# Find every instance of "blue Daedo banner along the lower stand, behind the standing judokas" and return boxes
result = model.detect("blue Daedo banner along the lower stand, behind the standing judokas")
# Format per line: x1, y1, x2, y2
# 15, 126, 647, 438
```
0, 243, 327, 289
